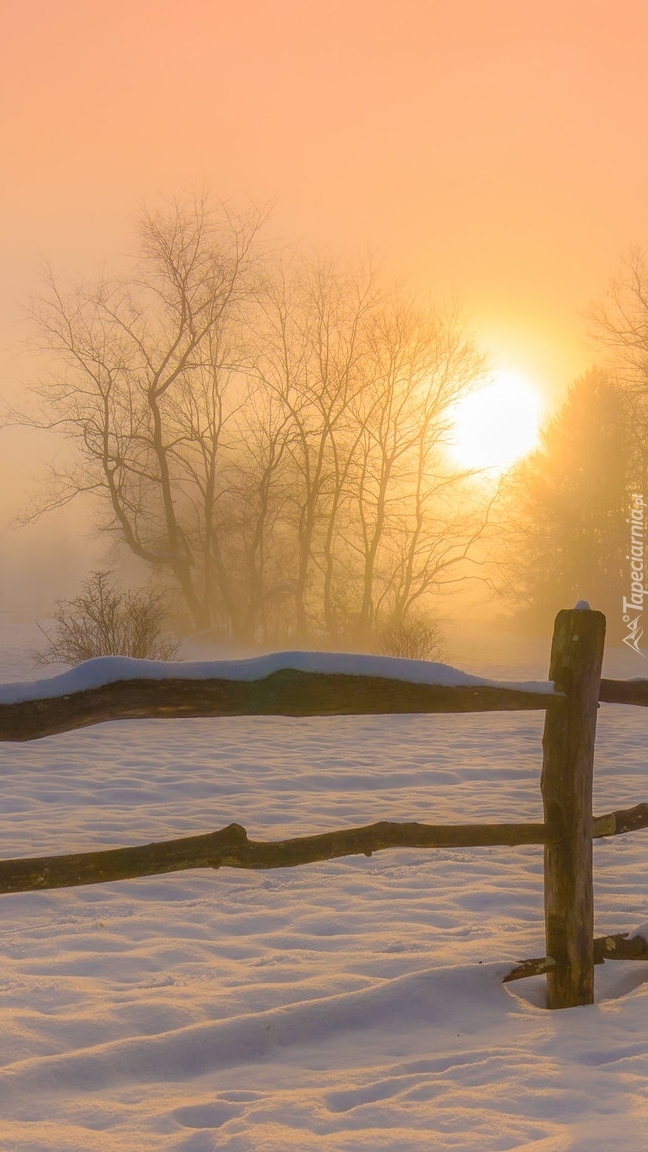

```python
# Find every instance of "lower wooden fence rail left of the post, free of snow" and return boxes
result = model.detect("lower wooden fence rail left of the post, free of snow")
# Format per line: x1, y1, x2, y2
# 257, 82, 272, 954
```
0, 820, 552, 894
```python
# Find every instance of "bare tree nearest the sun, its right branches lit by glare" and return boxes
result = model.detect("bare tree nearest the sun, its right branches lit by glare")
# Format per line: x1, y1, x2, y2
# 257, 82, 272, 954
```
343, 297, 484, 639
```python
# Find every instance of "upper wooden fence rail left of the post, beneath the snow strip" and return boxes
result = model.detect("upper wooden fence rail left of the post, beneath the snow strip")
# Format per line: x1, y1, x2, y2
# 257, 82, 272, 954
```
0, 668, 552, 741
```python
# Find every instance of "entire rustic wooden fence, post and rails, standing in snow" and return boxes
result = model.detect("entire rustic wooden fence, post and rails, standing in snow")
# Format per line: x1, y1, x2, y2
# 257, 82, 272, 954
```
0, 608, 648, 1008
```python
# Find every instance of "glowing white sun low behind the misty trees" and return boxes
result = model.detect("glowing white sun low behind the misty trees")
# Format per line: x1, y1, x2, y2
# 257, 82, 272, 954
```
450, 371, 542, 472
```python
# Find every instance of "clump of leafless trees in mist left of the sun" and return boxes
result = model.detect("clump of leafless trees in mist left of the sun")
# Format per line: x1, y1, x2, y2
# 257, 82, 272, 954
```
22, 203, 488, 645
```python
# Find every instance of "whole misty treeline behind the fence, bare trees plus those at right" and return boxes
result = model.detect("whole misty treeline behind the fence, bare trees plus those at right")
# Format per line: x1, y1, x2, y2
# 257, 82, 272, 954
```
22, 202, 648, 655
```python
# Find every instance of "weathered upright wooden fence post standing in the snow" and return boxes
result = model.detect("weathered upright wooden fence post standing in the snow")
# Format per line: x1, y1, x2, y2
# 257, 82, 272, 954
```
542, 605, 605, 1008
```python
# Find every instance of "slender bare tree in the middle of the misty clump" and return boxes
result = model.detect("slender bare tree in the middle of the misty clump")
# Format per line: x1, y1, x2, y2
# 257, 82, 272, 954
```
246, 253, 378, 639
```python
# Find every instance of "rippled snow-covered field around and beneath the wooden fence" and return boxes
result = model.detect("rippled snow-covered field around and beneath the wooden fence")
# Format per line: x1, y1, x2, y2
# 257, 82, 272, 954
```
0, 624, 648, 1152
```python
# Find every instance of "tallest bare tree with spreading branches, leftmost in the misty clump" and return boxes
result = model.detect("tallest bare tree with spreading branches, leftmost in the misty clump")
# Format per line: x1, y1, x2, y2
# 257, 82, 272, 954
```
20, 200, 263, 628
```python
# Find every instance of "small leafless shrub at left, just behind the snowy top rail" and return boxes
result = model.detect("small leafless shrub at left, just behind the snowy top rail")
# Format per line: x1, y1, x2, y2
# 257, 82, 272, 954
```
36, 571, 178, 664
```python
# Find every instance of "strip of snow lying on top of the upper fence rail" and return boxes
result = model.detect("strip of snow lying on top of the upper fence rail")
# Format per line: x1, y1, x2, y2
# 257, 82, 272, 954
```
0, 652, 555, 704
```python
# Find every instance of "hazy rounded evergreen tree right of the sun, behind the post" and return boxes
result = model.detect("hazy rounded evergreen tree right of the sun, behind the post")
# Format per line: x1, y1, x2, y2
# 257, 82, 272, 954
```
502, 369, 633, 643
